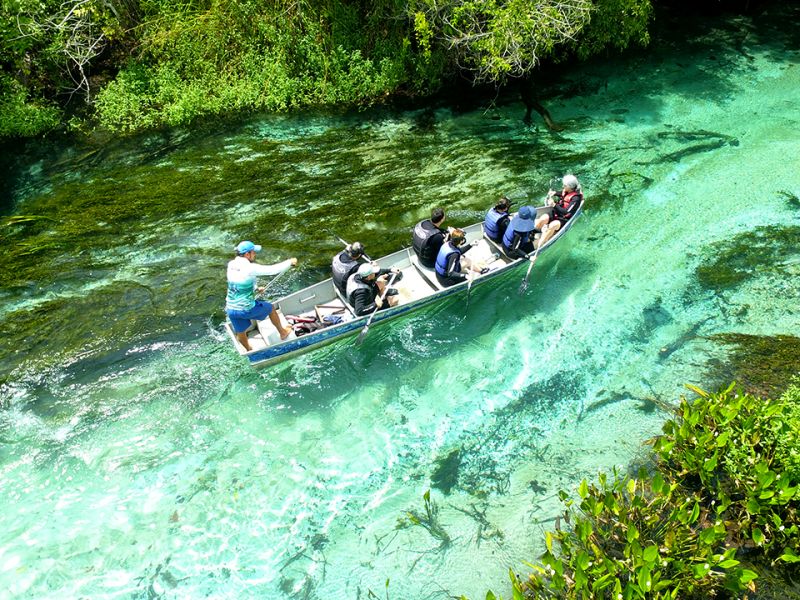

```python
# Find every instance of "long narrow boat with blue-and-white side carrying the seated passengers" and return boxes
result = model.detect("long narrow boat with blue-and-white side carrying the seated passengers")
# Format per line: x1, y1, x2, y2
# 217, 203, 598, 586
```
225, 202, 583, 367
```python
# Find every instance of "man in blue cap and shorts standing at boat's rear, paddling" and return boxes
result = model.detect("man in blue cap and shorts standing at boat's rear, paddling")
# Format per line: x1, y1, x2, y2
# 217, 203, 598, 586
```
225, 241, 297, 352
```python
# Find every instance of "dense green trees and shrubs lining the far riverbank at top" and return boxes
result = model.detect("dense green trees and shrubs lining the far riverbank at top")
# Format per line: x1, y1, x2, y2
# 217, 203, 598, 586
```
0, 0, 653, 136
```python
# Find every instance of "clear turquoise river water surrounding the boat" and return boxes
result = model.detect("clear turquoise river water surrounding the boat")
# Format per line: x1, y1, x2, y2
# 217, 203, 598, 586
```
0, 7, 800, 599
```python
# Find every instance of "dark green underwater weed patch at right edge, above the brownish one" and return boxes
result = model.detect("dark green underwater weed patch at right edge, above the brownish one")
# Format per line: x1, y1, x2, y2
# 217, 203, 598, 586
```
695, 226, 800, 292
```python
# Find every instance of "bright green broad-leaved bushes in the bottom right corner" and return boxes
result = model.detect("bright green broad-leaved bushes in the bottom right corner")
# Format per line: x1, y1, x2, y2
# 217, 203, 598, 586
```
494, 378, 800, 600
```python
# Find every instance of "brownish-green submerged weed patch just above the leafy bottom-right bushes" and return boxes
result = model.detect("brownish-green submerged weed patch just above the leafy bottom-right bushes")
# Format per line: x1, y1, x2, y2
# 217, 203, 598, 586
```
708, 333, 800, 398
